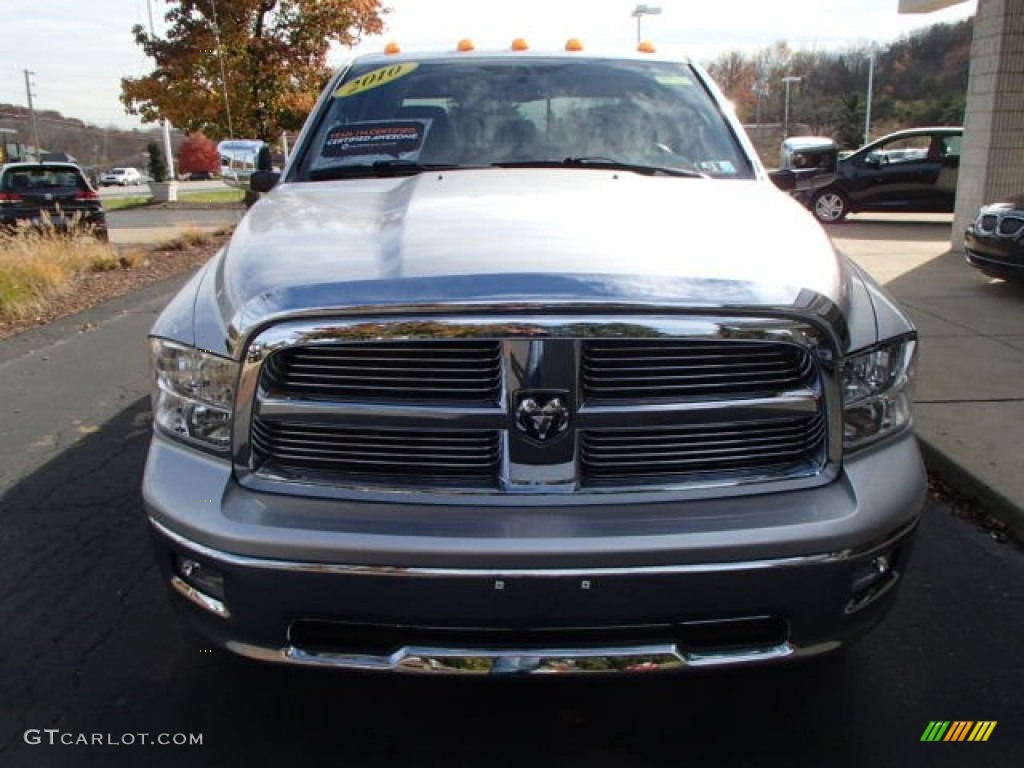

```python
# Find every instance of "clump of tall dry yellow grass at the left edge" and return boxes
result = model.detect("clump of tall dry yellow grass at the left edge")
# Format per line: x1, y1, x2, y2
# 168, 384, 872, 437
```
0, 231, 122, 321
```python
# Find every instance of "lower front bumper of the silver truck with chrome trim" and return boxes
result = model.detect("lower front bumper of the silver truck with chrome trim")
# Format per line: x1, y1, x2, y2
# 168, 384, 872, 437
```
151, 518, 915, 676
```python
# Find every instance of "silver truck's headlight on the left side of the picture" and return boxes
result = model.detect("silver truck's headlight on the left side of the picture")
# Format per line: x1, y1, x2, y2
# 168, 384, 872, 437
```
150, 339, 239, 452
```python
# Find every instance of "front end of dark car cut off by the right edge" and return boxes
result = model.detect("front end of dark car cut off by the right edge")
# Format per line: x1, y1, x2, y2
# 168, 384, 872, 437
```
964, 195, 1024, 280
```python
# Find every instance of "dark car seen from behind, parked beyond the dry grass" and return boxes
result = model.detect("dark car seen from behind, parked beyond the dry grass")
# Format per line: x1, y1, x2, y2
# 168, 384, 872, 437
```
0, 163, 106, 240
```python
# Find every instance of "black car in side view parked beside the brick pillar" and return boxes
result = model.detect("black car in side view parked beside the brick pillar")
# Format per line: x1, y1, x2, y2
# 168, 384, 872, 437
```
807, 128, 964, 224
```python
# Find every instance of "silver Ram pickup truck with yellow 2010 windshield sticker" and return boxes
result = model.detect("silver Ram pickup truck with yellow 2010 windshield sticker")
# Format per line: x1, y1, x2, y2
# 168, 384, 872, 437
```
143, 46, 925, 674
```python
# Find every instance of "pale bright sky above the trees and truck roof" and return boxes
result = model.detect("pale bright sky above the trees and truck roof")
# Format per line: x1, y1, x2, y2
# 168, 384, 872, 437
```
0, 0, 976, 128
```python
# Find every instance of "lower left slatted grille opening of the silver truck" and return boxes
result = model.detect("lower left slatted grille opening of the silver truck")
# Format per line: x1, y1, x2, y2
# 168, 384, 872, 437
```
252, 419, 500, 486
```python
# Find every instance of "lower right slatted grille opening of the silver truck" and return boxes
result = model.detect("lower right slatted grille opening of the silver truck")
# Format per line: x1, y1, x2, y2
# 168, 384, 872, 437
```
581, 414, 825, 481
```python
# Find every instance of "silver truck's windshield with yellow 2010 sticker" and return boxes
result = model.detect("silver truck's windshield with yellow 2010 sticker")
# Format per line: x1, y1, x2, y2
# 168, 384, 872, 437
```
297, 57, 753, 180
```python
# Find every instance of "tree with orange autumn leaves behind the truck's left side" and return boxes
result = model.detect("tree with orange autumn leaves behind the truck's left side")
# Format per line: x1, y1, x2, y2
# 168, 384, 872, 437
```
121, 0, 386, 140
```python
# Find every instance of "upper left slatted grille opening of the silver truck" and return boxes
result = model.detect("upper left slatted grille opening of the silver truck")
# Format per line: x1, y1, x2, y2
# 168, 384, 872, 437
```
263, 340, 501, 403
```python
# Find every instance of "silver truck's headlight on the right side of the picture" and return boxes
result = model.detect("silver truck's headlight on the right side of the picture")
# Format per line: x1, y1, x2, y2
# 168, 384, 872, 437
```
842, 337, 918, 451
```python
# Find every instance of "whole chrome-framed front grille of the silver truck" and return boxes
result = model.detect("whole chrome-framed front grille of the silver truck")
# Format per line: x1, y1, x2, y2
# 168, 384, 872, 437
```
241, 312, 842, 495
